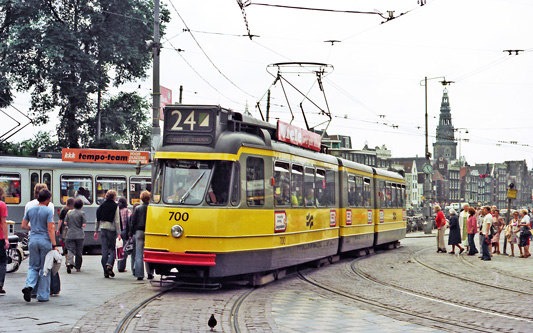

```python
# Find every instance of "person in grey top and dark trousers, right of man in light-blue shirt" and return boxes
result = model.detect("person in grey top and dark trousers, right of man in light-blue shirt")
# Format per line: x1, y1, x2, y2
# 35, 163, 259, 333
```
65, 199, 87, 274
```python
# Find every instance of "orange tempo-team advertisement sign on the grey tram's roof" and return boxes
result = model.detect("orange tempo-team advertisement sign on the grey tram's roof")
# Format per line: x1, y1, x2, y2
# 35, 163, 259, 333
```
61, 148, 150, 164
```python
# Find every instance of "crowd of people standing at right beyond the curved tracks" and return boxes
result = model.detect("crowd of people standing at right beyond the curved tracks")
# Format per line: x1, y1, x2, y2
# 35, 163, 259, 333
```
434, 204, 533, 261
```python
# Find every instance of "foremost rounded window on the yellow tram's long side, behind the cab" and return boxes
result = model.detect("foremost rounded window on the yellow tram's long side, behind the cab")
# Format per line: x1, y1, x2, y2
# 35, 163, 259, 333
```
246, 157, 265, 206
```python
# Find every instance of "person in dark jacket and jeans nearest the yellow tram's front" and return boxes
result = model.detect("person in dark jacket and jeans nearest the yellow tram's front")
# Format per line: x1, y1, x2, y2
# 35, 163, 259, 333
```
130, 191, 153, 280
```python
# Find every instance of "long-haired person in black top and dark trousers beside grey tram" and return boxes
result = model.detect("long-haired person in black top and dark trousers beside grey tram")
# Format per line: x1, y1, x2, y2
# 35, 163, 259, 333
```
94, 190, 121, 278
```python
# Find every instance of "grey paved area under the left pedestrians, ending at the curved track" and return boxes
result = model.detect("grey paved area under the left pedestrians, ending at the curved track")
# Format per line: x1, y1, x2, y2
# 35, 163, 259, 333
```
0, 255, 150, 332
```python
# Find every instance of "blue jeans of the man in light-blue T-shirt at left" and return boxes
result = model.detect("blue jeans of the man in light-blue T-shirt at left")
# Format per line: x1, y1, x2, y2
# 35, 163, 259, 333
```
26, 237, 52, 301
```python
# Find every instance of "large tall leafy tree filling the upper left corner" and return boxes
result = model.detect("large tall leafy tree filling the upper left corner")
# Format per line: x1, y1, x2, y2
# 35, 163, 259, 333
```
0, 0, 169, 148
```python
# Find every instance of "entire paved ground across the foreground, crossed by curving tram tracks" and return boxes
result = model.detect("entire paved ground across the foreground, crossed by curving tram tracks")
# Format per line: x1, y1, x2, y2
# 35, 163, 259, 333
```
0, 232, 533, 332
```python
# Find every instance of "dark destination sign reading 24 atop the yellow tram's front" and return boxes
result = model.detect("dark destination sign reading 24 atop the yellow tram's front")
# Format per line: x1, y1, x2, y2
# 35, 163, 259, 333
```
163, 106, 217, 145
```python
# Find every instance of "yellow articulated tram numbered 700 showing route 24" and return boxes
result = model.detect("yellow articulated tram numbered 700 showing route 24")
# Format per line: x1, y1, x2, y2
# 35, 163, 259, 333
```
144, 105, 405, 281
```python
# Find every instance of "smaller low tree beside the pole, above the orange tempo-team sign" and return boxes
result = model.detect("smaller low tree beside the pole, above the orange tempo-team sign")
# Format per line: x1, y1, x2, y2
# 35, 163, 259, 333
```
82, 92, 151, 150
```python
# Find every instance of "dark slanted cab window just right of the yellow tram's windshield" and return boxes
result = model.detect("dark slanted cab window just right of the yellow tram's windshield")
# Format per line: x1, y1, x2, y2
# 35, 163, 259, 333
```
205, 161, 233, 206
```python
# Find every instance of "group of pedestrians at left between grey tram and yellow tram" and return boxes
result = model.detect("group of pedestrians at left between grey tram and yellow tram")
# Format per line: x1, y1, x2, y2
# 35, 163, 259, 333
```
0, 183, 153, 302
